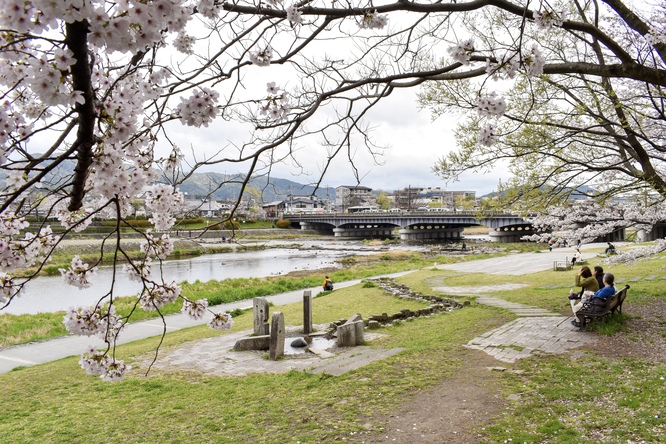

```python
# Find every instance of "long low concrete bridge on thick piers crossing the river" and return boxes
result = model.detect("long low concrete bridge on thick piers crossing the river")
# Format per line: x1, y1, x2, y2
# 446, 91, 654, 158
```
284, 211, 533, 242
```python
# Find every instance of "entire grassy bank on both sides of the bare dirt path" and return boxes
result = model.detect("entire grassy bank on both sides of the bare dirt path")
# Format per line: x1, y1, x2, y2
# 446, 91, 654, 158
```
0, 251, 666, 443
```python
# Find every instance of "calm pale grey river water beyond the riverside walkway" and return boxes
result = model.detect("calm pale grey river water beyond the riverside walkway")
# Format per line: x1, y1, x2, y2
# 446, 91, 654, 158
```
0, 241, 416, 314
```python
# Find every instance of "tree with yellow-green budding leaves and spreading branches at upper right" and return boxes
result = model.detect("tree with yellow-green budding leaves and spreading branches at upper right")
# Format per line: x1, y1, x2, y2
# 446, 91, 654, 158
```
420, 0, 666, 208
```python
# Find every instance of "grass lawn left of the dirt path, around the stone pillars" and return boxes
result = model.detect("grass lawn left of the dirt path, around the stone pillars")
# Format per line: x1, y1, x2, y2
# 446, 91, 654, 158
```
0, 286, 501, 443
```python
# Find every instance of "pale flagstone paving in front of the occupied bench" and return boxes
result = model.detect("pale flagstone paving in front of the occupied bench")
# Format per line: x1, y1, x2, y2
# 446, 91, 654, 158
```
466, 296, 596, 363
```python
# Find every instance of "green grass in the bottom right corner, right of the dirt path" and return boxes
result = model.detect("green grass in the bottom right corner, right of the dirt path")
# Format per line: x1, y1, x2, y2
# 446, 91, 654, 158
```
485, 356, 666, 444
